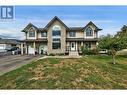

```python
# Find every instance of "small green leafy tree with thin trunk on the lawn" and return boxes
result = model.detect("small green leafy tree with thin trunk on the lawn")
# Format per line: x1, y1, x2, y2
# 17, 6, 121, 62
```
98, 34, 127, 64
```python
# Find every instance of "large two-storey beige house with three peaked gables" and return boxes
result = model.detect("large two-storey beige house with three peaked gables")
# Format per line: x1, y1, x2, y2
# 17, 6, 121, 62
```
21, 16, 101, 55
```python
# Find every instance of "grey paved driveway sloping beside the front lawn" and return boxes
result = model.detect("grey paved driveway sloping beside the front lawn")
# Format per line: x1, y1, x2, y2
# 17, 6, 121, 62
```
0, 55, 41, 75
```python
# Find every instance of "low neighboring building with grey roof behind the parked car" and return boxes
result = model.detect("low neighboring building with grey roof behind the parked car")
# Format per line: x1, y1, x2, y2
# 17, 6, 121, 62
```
0, 39, 20, 52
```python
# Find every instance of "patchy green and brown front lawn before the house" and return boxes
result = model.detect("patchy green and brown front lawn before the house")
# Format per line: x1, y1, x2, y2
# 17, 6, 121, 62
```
0, 55, 127, 89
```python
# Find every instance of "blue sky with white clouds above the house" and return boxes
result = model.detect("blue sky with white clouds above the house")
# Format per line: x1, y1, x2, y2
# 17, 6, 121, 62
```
0, 5, 127, 39
